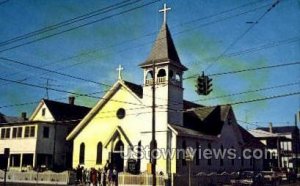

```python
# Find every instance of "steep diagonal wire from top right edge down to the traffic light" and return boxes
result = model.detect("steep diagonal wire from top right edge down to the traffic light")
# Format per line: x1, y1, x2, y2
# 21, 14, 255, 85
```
205, 0, 280, 71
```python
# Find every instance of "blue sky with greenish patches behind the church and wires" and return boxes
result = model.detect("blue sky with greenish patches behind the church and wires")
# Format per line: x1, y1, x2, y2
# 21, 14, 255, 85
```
0, 0, 300, 128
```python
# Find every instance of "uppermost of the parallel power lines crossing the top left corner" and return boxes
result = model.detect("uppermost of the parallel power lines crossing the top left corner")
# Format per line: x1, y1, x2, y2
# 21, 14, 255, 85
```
0, 0, 140, 47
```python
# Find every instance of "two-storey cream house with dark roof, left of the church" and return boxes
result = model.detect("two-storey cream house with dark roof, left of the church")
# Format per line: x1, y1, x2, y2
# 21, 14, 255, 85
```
0, 97, 90, 170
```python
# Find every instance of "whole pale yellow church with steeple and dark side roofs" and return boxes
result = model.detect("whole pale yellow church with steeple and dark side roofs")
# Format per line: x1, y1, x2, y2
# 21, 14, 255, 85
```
67, 3, 262, 182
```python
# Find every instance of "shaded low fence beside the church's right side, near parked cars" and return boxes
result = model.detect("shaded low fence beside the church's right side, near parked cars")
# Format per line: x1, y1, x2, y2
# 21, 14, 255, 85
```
174, 172, 236, 186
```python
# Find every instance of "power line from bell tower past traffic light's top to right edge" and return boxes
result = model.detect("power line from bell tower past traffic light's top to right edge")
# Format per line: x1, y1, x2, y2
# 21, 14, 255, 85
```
184, 61, 300, 80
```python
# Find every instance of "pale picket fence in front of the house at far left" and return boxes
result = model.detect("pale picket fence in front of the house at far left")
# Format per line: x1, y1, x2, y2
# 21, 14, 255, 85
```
0, 170, 75, 185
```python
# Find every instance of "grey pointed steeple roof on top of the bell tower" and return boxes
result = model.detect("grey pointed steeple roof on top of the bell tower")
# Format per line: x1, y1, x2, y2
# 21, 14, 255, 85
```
140, 24, 187, 70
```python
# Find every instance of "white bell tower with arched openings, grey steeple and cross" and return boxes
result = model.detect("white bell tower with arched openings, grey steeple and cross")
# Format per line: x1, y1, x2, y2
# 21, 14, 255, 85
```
139, 10, 187, 127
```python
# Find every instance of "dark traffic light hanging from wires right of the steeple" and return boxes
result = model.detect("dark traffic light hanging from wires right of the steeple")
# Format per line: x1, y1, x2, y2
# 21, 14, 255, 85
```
196, 72, 213, 96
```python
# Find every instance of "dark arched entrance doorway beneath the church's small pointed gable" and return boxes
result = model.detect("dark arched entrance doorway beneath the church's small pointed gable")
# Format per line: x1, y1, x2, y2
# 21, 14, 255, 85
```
111, 140, 124, 172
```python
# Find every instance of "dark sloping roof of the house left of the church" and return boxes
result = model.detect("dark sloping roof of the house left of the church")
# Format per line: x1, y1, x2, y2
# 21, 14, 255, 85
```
43, 99, 91, 121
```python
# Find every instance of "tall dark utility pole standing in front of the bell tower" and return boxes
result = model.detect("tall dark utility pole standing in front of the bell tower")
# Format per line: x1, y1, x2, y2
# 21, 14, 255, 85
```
150, 61, 157, 186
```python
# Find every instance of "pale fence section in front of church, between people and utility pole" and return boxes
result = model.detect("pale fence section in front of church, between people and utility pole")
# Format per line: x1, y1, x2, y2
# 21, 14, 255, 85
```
118, 173, 165, 186
